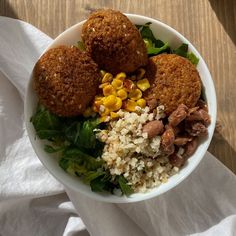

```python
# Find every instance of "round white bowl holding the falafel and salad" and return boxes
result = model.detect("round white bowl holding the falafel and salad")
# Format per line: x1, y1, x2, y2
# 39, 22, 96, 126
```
25, 14, 216, 203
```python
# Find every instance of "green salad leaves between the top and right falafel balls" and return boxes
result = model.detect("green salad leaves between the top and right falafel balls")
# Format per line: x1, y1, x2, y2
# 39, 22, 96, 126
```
136, 22, 199, 65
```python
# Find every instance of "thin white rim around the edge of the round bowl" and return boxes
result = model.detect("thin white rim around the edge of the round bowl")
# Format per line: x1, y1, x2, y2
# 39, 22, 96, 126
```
24, 13, 217, 203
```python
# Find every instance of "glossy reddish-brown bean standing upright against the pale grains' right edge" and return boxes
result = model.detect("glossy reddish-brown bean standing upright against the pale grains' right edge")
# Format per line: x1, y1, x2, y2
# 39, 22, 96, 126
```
161, 126, 175, 154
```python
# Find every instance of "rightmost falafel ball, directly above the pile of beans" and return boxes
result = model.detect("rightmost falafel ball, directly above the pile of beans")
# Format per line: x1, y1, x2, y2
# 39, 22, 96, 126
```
144, 54, 201, 115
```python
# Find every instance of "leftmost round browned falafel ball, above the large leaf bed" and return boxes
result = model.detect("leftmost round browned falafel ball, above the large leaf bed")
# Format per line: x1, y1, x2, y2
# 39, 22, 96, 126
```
33, 46, 100, 116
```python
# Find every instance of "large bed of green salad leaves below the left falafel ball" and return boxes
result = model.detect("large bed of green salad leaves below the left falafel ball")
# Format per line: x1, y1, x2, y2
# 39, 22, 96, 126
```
31, 105, 133, 195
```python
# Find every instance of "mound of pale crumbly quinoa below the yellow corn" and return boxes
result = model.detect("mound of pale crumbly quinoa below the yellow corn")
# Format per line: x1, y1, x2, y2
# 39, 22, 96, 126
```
97, 106, 179, 192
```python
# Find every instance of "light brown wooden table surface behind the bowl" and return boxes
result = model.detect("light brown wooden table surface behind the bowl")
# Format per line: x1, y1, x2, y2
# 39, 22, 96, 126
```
0, 0, 236, 173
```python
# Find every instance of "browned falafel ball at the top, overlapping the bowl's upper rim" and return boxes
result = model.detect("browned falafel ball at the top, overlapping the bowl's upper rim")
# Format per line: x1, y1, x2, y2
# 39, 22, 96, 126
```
82, 9, 148, 74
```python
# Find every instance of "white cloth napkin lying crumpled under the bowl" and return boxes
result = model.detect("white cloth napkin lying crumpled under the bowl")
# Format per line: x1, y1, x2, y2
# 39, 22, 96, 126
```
0, 17, 236, 236
